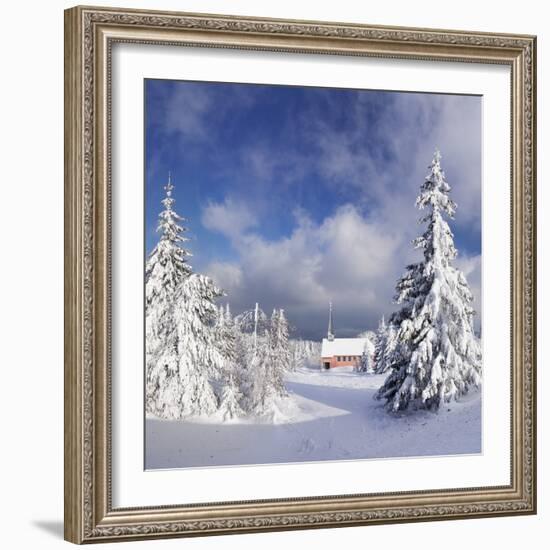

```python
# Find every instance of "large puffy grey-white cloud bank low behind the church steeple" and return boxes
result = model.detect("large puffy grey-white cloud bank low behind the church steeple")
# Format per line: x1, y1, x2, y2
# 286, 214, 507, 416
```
206, 204, 418, 337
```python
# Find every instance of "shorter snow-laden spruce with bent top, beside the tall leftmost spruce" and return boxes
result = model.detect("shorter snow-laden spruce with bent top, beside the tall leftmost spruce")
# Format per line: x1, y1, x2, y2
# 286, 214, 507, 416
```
156, 274, 225, 418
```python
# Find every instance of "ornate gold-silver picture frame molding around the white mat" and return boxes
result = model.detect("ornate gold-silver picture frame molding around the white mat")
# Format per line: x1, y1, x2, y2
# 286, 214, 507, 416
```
64, 7, 536, 543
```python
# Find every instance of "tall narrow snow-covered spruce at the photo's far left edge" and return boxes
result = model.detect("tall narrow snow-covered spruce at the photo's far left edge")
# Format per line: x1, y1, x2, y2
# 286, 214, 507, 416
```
145, 175, 191, 414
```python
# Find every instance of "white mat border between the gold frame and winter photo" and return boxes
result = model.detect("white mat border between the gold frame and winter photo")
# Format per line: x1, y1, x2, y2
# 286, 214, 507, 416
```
112, 43, 511, 508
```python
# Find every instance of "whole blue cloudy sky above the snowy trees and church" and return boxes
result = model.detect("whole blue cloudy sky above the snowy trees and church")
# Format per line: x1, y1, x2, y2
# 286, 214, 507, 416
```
145, 80, 482, 339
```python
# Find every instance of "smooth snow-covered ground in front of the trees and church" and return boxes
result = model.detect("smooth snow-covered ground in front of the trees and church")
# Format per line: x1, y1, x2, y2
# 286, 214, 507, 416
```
145, 368, 481, 469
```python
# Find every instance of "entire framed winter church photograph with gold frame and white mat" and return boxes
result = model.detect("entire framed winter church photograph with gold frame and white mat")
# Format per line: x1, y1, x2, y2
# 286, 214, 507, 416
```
65, 7, 536, 543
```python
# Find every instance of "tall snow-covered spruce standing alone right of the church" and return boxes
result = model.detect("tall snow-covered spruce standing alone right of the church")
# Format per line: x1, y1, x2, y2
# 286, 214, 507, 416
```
377, 150, 481, 411
